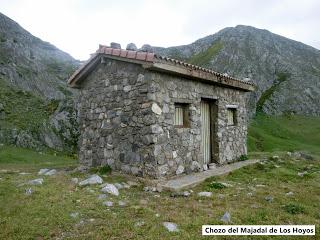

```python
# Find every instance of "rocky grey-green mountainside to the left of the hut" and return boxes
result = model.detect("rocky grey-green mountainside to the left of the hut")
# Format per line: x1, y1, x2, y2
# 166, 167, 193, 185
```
0, 13, 79, 150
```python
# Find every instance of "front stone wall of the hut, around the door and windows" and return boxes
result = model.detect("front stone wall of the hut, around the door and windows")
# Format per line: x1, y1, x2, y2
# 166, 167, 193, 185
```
148, 72, 247, 177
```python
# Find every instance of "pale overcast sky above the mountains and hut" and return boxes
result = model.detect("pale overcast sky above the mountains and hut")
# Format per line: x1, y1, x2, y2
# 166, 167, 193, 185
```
0, 0, 320, 60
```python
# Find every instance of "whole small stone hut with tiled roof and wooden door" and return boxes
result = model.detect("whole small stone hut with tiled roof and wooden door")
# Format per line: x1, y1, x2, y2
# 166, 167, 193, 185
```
68, 45, 255, 179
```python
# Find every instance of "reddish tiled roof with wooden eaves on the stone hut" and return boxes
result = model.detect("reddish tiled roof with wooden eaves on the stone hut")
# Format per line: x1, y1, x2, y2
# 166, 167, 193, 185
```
68, 45, 255, 91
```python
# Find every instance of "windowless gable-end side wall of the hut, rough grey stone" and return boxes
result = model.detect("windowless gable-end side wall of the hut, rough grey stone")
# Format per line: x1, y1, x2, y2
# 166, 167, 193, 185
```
78, 60, 156, 176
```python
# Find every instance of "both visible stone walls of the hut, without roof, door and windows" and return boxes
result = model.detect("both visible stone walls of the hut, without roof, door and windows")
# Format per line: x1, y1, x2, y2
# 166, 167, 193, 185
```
78, 59, 247, 178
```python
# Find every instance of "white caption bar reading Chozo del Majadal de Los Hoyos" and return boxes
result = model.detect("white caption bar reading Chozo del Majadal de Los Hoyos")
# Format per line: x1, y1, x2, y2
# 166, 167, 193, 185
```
202, 225, 316, 236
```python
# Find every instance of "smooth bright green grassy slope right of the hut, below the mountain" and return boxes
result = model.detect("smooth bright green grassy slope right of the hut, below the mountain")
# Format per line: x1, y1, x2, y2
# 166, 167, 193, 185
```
248, 114, 320, 153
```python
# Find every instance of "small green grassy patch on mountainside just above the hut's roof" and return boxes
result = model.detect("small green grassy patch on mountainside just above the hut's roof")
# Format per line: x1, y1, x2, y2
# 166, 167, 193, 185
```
187, 42, 223, 66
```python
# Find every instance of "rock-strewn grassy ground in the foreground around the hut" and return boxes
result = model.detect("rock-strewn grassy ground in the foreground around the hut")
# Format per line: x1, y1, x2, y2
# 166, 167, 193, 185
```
0, 147, 320, 240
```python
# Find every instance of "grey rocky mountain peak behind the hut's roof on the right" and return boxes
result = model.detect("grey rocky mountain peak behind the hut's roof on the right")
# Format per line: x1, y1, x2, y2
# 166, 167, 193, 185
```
154, 25, 320, 116
